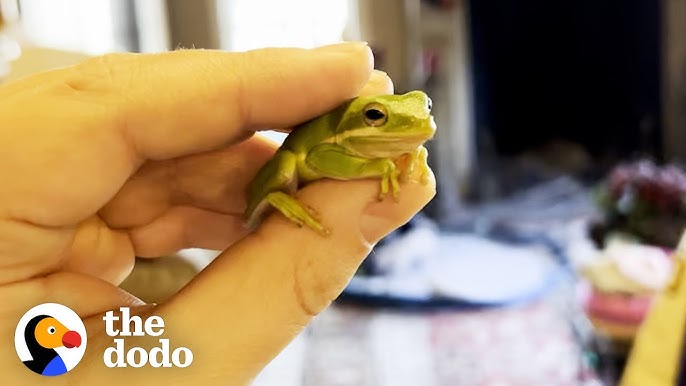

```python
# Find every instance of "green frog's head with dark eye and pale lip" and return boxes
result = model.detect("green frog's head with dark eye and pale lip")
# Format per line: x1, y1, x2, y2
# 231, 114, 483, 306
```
335, 91, 436, 158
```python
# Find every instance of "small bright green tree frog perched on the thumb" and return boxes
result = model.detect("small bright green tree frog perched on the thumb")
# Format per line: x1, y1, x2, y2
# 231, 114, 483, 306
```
244, 91, 436, 235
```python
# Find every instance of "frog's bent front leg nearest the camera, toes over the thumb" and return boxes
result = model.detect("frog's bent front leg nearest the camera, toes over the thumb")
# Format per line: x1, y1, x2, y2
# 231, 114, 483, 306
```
305, 144, 400, 201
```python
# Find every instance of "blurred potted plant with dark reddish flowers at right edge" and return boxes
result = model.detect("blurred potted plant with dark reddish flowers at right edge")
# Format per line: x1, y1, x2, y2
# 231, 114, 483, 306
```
581, 160, 686, 341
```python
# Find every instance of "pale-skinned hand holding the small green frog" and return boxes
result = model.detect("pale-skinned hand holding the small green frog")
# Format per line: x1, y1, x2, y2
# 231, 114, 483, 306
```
0, 40, 435, 385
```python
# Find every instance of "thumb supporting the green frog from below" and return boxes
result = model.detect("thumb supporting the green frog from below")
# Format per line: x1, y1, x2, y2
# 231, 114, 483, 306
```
155, 172, 435, 384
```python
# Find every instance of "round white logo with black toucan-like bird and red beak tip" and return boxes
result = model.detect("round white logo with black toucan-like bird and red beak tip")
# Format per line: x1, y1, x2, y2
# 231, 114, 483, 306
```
14, 303, 87, 376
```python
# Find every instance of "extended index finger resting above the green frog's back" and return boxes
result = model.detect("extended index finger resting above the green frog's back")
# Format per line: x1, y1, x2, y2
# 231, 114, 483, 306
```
118, 43, 373, 159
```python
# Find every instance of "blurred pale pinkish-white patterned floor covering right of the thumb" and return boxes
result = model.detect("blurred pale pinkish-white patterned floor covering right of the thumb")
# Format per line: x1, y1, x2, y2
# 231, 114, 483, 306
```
254, 301, 581, 386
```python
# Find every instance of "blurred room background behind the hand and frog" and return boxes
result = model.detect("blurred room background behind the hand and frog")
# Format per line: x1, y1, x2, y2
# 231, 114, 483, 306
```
0, 0, 686, 386
